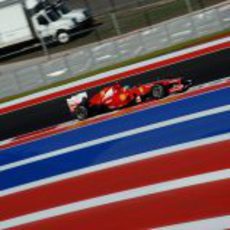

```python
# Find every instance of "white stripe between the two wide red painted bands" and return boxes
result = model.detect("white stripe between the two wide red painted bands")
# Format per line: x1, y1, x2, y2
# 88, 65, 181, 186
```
1, 169, 230, 229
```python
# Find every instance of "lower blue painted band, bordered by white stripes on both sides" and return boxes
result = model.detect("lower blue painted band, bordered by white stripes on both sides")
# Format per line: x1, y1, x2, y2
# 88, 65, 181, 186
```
0, 112, 230, 190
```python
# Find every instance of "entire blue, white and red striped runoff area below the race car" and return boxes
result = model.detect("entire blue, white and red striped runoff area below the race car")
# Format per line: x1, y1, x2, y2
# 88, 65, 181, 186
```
0, 82, 230, 229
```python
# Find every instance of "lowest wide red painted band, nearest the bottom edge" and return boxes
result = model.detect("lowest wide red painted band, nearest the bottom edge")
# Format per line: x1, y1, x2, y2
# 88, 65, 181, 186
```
14, 180, 230, 230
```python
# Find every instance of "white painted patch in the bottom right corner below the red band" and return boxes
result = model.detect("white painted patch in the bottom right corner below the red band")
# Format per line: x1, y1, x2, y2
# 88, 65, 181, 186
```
155, 216, 230, 230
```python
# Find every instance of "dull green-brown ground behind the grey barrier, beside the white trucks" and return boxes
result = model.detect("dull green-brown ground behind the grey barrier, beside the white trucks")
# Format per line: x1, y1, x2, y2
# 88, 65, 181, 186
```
0, 0, 224, 59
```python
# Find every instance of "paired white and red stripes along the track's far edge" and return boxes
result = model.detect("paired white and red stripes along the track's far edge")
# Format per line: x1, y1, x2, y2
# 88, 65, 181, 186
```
0, 37, 230, 114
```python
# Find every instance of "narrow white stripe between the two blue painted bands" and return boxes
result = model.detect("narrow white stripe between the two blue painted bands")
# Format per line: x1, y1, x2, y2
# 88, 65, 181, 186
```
0, 105, 230, 171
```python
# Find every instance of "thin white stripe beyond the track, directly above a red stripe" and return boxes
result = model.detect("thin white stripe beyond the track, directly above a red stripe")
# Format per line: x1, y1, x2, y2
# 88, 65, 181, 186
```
0, 36, 230, 109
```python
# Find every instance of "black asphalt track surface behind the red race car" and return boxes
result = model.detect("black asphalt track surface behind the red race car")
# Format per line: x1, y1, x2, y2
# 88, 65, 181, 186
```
0, 49, 230, 140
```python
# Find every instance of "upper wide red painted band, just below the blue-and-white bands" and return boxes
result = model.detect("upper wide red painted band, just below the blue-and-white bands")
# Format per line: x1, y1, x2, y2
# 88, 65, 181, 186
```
0, 141, 230, 221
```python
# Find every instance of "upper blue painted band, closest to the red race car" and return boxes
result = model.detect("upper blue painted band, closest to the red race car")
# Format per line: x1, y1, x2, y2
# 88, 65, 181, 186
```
0, 88, 230, 165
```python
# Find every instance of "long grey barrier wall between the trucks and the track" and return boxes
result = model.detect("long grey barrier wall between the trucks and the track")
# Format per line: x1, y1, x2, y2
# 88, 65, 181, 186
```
0, 1, 230, 98
